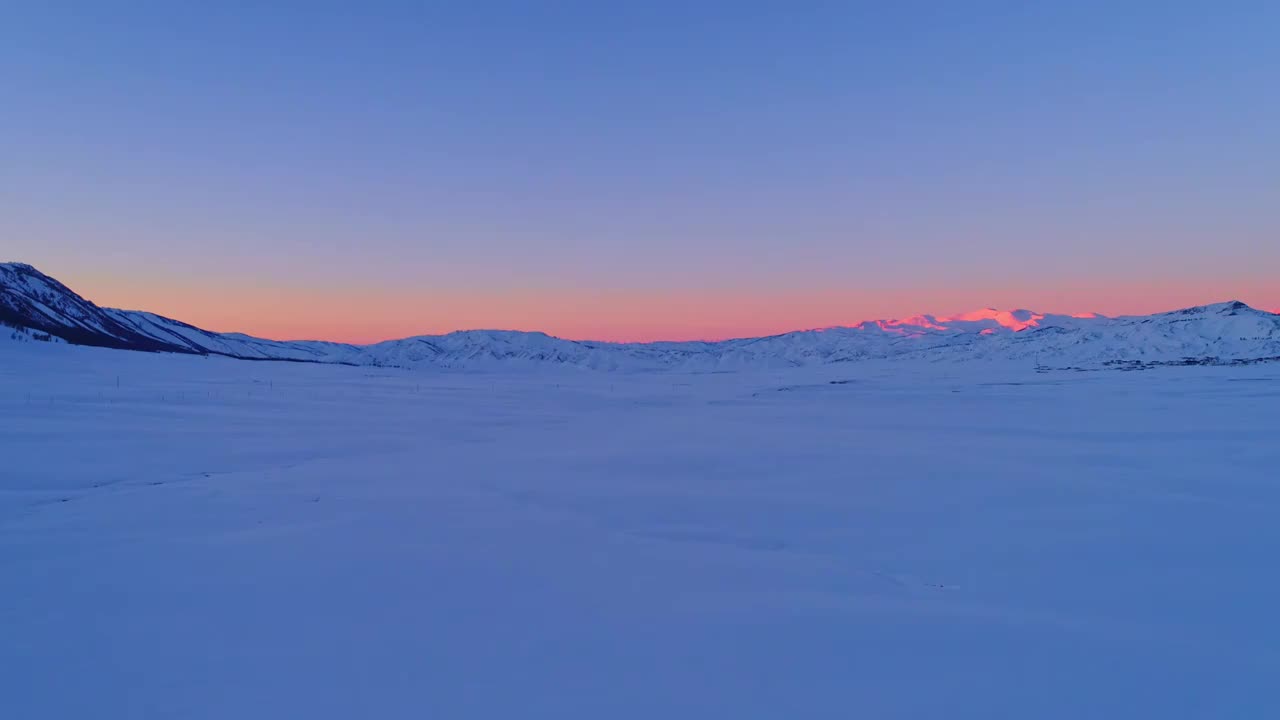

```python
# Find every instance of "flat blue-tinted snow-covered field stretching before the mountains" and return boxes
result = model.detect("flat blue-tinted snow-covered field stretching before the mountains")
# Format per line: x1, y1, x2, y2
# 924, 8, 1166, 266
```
0, 342, 1280, 720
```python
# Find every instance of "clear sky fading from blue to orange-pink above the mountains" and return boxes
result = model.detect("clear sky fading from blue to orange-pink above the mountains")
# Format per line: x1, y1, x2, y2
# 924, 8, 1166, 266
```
0, 0, 1280, 342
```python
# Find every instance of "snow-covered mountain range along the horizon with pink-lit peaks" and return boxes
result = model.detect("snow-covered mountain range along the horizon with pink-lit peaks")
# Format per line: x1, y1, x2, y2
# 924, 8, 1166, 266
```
0, 263, 1280, 370
